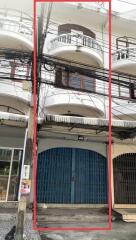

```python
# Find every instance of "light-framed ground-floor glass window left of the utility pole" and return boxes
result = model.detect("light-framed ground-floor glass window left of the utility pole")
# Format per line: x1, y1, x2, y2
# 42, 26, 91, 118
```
0, 148, 23, 201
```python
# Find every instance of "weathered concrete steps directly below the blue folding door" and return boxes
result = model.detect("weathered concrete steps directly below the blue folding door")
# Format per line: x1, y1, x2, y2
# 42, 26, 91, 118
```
37, 208, 108, 227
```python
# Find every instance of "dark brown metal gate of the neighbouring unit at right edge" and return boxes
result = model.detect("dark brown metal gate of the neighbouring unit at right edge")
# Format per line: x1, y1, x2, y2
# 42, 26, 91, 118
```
113, 153, 136, 204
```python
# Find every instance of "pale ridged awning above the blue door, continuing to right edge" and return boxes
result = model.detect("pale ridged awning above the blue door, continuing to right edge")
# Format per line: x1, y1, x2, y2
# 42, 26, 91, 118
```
40, 115, 136, 139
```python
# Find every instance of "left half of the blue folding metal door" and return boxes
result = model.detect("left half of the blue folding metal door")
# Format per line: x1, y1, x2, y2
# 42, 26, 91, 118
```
37, 148, 72, 203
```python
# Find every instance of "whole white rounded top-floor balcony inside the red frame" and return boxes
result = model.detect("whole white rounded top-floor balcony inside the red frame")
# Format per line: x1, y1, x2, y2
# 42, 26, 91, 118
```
48, 33, 103, 66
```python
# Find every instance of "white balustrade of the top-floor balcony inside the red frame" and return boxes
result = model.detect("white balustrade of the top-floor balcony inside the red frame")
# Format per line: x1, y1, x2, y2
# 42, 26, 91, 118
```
49, 33, 103, 57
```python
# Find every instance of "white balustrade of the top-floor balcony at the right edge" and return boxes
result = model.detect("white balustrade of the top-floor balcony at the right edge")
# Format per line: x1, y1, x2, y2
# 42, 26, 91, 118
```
112, 47, 136, 63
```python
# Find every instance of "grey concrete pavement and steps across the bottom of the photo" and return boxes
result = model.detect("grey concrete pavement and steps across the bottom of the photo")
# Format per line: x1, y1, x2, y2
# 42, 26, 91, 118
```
0, 208, 136, 240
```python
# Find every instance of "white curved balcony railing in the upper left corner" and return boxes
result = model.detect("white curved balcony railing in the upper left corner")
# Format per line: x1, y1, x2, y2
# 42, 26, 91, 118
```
0, 9, 33, 40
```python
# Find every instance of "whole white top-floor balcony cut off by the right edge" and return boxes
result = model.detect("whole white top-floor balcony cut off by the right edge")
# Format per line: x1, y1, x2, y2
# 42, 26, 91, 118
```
112, 47, 136, 74
